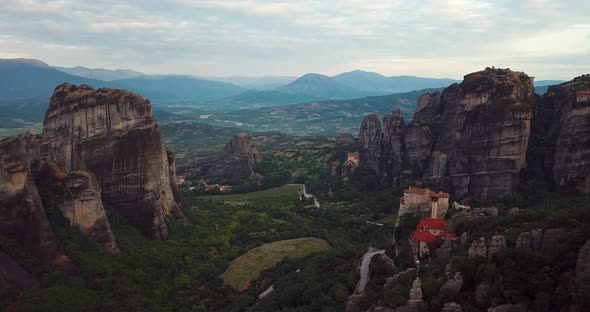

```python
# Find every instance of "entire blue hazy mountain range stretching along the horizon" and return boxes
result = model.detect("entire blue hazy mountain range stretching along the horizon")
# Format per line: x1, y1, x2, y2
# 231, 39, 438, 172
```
0, 59, 572, 128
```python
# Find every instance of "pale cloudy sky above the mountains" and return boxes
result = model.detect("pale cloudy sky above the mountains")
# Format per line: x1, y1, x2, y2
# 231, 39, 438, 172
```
0, 0, 590, 80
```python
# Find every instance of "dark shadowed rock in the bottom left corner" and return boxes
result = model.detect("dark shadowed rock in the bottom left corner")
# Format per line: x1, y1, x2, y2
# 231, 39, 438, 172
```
0, 251, 39, 296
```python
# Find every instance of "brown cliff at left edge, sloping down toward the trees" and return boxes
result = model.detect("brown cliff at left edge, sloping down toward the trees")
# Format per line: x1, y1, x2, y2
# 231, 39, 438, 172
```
0, 136, 72, 269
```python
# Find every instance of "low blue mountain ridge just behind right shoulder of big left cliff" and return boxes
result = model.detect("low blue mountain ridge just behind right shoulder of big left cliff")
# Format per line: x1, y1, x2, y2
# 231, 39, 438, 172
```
109, 76, 245, 102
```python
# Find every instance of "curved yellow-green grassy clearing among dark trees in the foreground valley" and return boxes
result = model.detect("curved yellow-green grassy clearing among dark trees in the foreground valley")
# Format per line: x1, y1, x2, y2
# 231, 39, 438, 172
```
223, 237, 331, 290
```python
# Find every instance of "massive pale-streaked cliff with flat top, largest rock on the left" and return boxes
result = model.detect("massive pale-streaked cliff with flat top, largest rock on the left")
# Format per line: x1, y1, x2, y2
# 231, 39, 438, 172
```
42, 83, 176, 239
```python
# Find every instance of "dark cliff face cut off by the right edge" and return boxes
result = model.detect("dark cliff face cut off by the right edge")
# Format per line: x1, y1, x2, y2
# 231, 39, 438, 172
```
543, 75, 590, 193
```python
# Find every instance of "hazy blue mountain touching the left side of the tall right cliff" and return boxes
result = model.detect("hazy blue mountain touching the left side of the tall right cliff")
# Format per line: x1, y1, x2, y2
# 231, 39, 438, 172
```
332, 70, 460, 93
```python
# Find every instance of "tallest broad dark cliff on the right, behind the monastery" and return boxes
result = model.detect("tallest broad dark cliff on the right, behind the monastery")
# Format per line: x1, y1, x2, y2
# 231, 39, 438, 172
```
420, 69, 534, 201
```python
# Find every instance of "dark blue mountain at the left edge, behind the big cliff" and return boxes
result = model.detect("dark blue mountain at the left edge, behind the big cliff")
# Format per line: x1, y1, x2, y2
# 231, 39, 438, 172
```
0, 59, 105, 102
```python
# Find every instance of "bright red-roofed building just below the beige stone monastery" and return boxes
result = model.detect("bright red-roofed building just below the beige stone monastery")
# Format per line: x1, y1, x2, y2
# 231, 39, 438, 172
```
412, 218, 457, 259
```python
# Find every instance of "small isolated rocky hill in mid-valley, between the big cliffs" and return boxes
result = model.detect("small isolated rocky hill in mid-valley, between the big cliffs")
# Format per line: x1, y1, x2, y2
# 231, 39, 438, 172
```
190, 133, 262, 182
